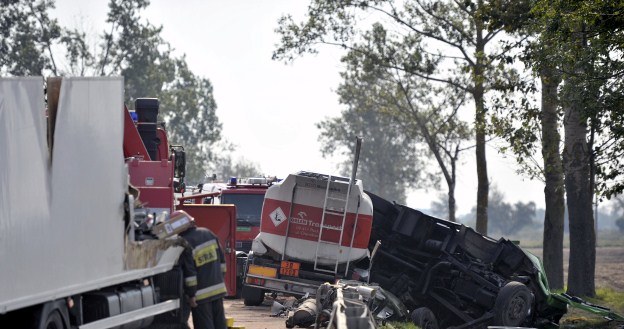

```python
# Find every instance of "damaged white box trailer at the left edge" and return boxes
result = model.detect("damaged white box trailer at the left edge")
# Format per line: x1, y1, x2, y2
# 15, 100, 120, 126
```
0, 77, 183, 328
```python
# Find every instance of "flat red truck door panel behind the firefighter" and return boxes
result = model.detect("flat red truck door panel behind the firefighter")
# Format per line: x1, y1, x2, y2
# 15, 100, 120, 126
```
177, 204, 236, 296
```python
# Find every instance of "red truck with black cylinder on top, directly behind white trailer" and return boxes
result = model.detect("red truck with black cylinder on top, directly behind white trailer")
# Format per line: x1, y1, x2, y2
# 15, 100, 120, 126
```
124, 98, 236, 296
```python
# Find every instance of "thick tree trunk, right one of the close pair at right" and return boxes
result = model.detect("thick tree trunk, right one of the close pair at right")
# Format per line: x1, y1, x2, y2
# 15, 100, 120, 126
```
563, 79, 596, 296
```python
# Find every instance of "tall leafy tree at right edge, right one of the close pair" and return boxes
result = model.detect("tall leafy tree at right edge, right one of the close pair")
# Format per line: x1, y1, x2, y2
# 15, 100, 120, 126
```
533, 0, 624, 296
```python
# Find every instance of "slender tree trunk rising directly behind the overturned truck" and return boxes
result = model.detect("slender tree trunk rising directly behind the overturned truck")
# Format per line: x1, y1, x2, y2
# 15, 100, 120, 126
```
473, 26, 490, 235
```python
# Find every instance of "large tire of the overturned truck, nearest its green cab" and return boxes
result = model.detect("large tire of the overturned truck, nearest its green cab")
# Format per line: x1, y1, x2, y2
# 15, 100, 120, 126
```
494, 281, 533, 327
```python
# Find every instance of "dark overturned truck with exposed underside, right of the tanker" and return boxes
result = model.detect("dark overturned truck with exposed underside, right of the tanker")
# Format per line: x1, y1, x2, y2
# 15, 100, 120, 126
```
368, 193, 567, 328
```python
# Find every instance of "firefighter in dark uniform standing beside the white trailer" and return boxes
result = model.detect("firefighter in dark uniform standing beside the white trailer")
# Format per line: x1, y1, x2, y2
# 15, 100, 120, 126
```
179, 210, 226, 329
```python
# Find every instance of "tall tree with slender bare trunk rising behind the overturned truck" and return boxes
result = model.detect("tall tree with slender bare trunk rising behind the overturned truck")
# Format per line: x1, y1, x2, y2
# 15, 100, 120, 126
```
273, 0, 511, 233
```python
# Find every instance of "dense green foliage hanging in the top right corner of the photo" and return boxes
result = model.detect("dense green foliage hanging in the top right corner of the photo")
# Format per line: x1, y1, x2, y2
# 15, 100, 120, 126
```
532, 0, 624, 198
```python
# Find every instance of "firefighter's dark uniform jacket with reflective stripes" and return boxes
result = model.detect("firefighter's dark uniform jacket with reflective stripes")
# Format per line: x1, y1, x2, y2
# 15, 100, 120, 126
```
180, 227, 226, 304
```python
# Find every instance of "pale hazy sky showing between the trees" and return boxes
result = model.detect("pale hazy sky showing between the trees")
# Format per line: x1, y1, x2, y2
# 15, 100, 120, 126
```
54, 0, 544, 214
